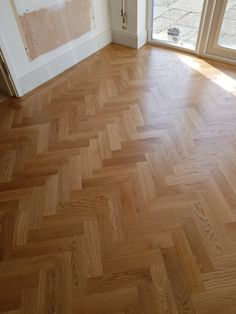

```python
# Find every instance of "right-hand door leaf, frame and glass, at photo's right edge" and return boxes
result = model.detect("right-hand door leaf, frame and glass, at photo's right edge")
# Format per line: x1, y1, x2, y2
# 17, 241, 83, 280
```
207, 0, 236, 60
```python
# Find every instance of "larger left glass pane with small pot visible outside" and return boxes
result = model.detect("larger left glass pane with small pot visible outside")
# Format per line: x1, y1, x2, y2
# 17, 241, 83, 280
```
151, 0, 204, 51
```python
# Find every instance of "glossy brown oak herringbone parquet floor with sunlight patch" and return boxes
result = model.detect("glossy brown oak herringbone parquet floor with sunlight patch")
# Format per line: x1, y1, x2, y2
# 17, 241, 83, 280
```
0, 45, 236, 314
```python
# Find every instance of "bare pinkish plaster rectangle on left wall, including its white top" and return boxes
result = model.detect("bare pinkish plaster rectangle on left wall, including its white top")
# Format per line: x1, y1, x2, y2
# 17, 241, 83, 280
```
12, 0, 91, 59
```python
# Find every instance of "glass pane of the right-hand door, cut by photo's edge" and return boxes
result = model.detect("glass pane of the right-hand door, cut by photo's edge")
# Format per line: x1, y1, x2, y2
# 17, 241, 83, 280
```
218, 0, 236, 49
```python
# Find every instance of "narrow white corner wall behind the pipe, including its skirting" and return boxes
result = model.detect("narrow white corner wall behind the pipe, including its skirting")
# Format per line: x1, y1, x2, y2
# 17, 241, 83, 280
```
110, 0, 147, 48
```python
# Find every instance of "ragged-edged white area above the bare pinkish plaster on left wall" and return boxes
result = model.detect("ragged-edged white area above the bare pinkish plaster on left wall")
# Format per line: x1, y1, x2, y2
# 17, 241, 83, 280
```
15, 0, 71, 15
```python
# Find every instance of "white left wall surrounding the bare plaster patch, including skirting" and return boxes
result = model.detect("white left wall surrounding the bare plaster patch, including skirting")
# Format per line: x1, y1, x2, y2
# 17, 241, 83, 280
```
0, 0, 111, 95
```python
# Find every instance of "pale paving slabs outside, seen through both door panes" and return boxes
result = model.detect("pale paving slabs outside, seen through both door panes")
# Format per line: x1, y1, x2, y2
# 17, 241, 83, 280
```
153, 0, 236, 49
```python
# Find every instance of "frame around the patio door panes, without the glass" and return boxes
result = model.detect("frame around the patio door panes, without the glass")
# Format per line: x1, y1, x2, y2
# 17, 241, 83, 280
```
147, 0, 236, 65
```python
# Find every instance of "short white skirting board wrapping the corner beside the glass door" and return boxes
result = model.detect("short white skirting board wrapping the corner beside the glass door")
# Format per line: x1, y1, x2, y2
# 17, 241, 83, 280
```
112, 29, 147, 49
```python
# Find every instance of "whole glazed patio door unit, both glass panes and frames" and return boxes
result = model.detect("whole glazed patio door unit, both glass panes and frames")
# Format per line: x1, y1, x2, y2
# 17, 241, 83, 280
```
149, 0, 236, 64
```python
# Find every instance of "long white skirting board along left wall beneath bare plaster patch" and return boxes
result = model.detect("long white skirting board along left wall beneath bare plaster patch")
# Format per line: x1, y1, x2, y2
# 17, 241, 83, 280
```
17, 29, 112, 96
